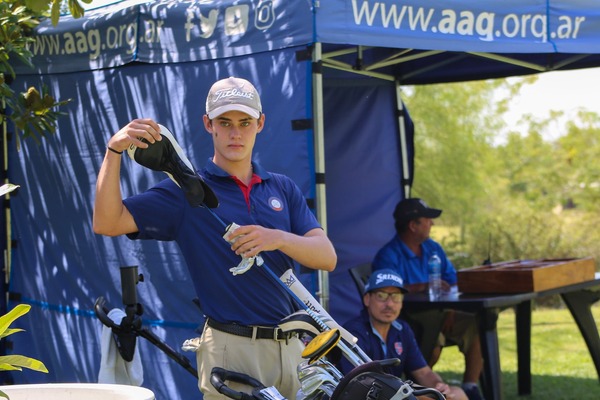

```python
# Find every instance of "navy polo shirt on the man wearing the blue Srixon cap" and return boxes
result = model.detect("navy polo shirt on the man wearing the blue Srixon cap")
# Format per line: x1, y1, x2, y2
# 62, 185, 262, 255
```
339, 308, 427, 377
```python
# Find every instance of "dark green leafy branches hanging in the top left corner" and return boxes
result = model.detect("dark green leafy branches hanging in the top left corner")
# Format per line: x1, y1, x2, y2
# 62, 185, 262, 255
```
0, 0, 91, 145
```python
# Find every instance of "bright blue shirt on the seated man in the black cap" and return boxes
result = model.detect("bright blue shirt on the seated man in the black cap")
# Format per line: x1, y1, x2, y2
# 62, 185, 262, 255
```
372, 235, 457, 285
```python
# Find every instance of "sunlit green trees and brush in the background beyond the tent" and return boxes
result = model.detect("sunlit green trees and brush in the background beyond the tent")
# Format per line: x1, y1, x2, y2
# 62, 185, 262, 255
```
405, 77, 600, 268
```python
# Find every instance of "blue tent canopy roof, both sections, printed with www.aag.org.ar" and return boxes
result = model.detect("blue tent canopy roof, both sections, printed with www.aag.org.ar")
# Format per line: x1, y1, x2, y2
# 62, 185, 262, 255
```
18, 0, 600, 85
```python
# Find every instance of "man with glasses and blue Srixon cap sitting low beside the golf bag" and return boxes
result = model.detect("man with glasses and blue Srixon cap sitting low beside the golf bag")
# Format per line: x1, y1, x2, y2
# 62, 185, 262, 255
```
340, 269, 467, 400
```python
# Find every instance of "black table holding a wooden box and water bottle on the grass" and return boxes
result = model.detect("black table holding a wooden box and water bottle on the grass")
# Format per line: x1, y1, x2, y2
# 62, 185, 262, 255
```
404, 273, 600, 400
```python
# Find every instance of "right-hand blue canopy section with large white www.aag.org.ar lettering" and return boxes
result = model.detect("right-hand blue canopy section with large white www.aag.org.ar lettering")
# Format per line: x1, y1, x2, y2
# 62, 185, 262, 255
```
316, 0, 600, 84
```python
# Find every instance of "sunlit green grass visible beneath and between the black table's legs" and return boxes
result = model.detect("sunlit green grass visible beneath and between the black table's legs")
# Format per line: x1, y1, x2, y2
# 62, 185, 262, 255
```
434, 303, 600, 400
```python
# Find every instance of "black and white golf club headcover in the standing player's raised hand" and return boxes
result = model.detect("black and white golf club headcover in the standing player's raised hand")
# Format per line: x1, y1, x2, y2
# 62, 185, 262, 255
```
127, 124, 219, 208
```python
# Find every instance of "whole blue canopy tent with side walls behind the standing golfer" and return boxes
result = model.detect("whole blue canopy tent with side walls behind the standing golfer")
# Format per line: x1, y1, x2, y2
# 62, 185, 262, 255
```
4, 0, 600, 399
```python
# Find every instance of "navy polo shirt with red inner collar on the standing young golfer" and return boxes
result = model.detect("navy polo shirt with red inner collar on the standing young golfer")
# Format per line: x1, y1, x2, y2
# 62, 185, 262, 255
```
123, 159, 320, 326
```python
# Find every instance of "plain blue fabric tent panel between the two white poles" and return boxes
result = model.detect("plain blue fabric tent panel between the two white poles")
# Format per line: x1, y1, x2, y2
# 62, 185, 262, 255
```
324, 79, 412, 323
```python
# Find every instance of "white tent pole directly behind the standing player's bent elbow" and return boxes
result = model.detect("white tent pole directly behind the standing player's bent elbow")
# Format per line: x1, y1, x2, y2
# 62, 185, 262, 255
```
312, 42, 329, 311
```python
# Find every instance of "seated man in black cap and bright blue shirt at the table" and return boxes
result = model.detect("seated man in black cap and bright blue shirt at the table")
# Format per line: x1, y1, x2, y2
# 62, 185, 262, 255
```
373, 198, 483, 400
